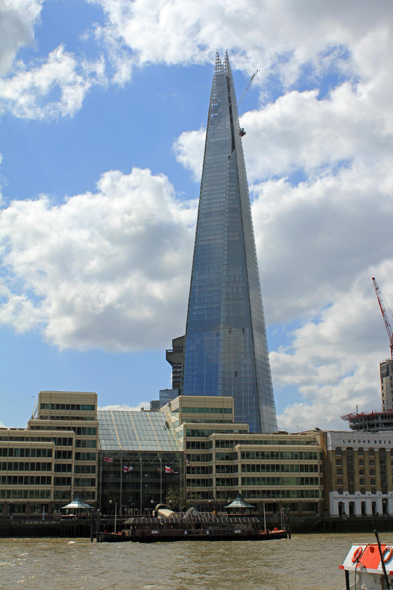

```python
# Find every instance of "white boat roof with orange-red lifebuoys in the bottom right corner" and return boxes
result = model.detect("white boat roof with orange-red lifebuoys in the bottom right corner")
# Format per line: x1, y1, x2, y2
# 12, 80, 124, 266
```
339, 543, 393, 576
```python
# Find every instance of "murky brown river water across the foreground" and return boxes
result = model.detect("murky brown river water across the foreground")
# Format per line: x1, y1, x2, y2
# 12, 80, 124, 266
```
0, 534, 393, 590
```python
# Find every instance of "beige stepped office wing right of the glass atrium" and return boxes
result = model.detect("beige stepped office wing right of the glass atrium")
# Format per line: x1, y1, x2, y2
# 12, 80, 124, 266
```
162, 395, 326, 516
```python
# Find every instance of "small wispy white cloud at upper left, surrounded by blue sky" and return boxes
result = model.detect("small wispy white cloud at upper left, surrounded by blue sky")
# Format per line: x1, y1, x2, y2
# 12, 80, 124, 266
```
0, 46, 105, 119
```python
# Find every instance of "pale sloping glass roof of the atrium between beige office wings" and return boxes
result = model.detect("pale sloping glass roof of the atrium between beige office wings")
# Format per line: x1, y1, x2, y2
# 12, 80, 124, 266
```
97, 410, 181, 451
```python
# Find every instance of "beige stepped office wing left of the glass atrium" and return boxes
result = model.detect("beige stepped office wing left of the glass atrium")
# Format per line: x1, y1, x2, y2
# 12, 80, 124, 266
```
0, 391, 99, 516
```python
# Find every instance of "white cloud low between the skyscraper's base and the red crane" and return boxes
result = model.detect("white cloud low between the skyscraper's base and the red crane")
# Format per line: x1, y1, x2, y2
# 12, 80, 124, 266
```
270, 270, 393, 430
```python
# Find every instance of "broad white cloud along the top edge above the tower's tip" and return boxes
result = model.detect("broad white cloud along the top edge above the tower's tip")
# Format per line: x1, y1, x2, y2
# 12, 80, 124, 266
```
88, 0, 392, 85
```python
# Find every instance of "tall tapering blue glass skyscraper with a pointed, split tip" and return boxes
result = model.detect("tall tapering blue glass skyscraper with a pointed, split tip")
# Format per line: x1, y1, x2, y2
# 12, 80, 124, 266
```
182, 55, 277, 433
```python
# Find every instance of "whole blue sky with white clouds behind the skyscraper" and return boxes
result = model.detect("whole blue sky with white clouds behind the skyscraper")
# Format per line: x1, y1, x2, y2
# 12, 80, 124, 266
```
0, 0, 393, 432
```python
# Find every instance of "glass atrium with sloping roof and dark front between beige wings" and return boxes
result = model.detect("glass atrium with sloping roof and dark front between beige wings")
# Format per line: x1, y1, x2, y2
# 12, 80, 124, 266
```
98, 410, 185, 514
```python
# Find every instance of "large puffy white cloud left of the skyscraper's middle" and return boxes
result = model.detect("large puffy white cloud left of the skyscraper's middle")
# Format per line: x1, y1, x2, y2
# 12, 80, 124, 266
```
0, 169, 196, 350
